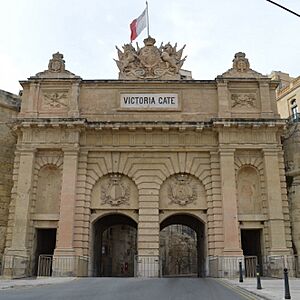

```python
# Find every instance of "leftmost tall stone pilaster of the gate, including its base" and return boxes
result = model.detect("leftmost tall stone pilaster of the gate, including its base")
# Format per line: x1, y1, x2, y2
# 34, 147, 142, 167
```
4, 150, 35, 275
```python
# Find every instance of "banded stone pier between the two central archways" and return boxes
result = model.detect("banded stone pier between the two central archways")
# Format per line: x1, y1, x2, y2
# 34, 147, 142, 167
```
137, 183, 160, 277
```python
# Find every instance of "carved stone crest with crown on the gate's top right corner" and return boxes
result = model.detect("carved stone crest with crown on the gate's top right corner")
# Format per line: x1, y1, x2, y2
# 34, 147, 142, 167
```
222, 52, 267, 78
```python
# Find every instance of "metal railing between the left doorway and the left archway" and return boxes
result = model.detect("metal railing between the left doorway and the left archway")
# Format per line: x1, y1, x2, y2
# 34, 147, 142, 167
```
37, 255, 89, 277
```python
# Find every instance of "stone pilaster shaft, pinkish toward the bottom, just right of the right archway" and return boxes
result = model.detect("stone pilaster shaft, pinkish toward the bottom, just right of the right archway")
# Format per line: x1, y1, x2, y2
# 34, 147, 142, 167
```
220, 149, 243, 256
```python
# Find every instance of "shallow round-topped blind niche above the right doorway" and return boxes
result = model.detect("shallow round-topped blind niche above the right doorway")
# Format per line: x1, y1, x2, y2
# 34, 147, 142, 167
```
237, 166, 262, 214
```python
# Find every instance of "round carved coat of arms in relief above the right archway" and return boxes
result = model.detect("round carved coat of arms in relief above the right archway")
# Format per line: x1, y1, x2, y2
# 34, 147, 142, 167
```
168, 174, 197, 206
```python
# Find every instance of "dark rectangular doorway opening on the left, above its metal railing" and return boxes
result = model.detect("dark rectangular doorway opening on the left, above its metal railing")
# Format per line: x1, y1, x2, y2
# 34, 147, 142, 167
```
34, 228, 56, 275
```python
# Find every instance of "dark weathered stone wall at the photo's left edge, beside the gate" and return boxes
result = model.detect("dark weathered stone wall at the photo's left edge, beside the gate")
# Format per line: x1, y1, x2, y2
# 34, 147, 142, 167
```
0, 90, 20, 258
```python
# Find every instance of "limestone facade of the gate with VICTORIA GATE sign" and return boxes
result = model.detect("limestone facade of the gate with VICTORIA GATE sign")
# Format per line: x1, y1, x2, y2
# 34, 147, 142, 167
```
1, 45, 293, 276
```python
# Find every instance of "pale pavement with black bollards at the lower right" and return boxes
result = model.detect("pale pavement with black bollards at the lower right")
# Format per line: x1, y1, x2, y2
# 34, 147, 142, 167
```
220, 278, 300, 300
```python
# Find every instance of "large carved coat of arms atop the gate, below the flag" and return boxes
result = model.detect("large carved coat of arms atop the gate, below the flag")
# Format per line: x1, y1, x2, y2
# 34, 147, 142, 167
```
115, 37, 186, 80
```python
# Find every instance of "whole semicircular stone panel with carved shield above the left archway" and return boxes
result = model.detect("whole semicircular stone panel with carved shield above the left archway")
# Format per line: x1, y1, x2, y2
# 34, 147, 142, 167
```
91, 173, 138, 209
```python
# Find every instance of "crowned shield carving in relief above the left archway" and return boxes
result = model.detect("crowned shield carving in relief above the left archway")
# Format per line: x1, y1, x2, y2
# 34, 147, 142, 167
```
101, 174, 130, 206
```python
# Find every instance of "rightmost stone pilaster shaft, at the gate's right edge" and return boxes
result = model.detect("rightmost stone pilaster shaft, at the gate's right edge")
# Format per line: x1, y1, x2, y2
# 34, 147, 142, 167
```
264, 149, 288, 255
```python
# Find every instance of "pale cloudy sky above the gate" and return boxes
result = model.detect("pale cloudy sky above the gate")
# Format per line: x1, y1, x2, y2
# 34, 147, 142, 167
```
0, 0, 300, 94
